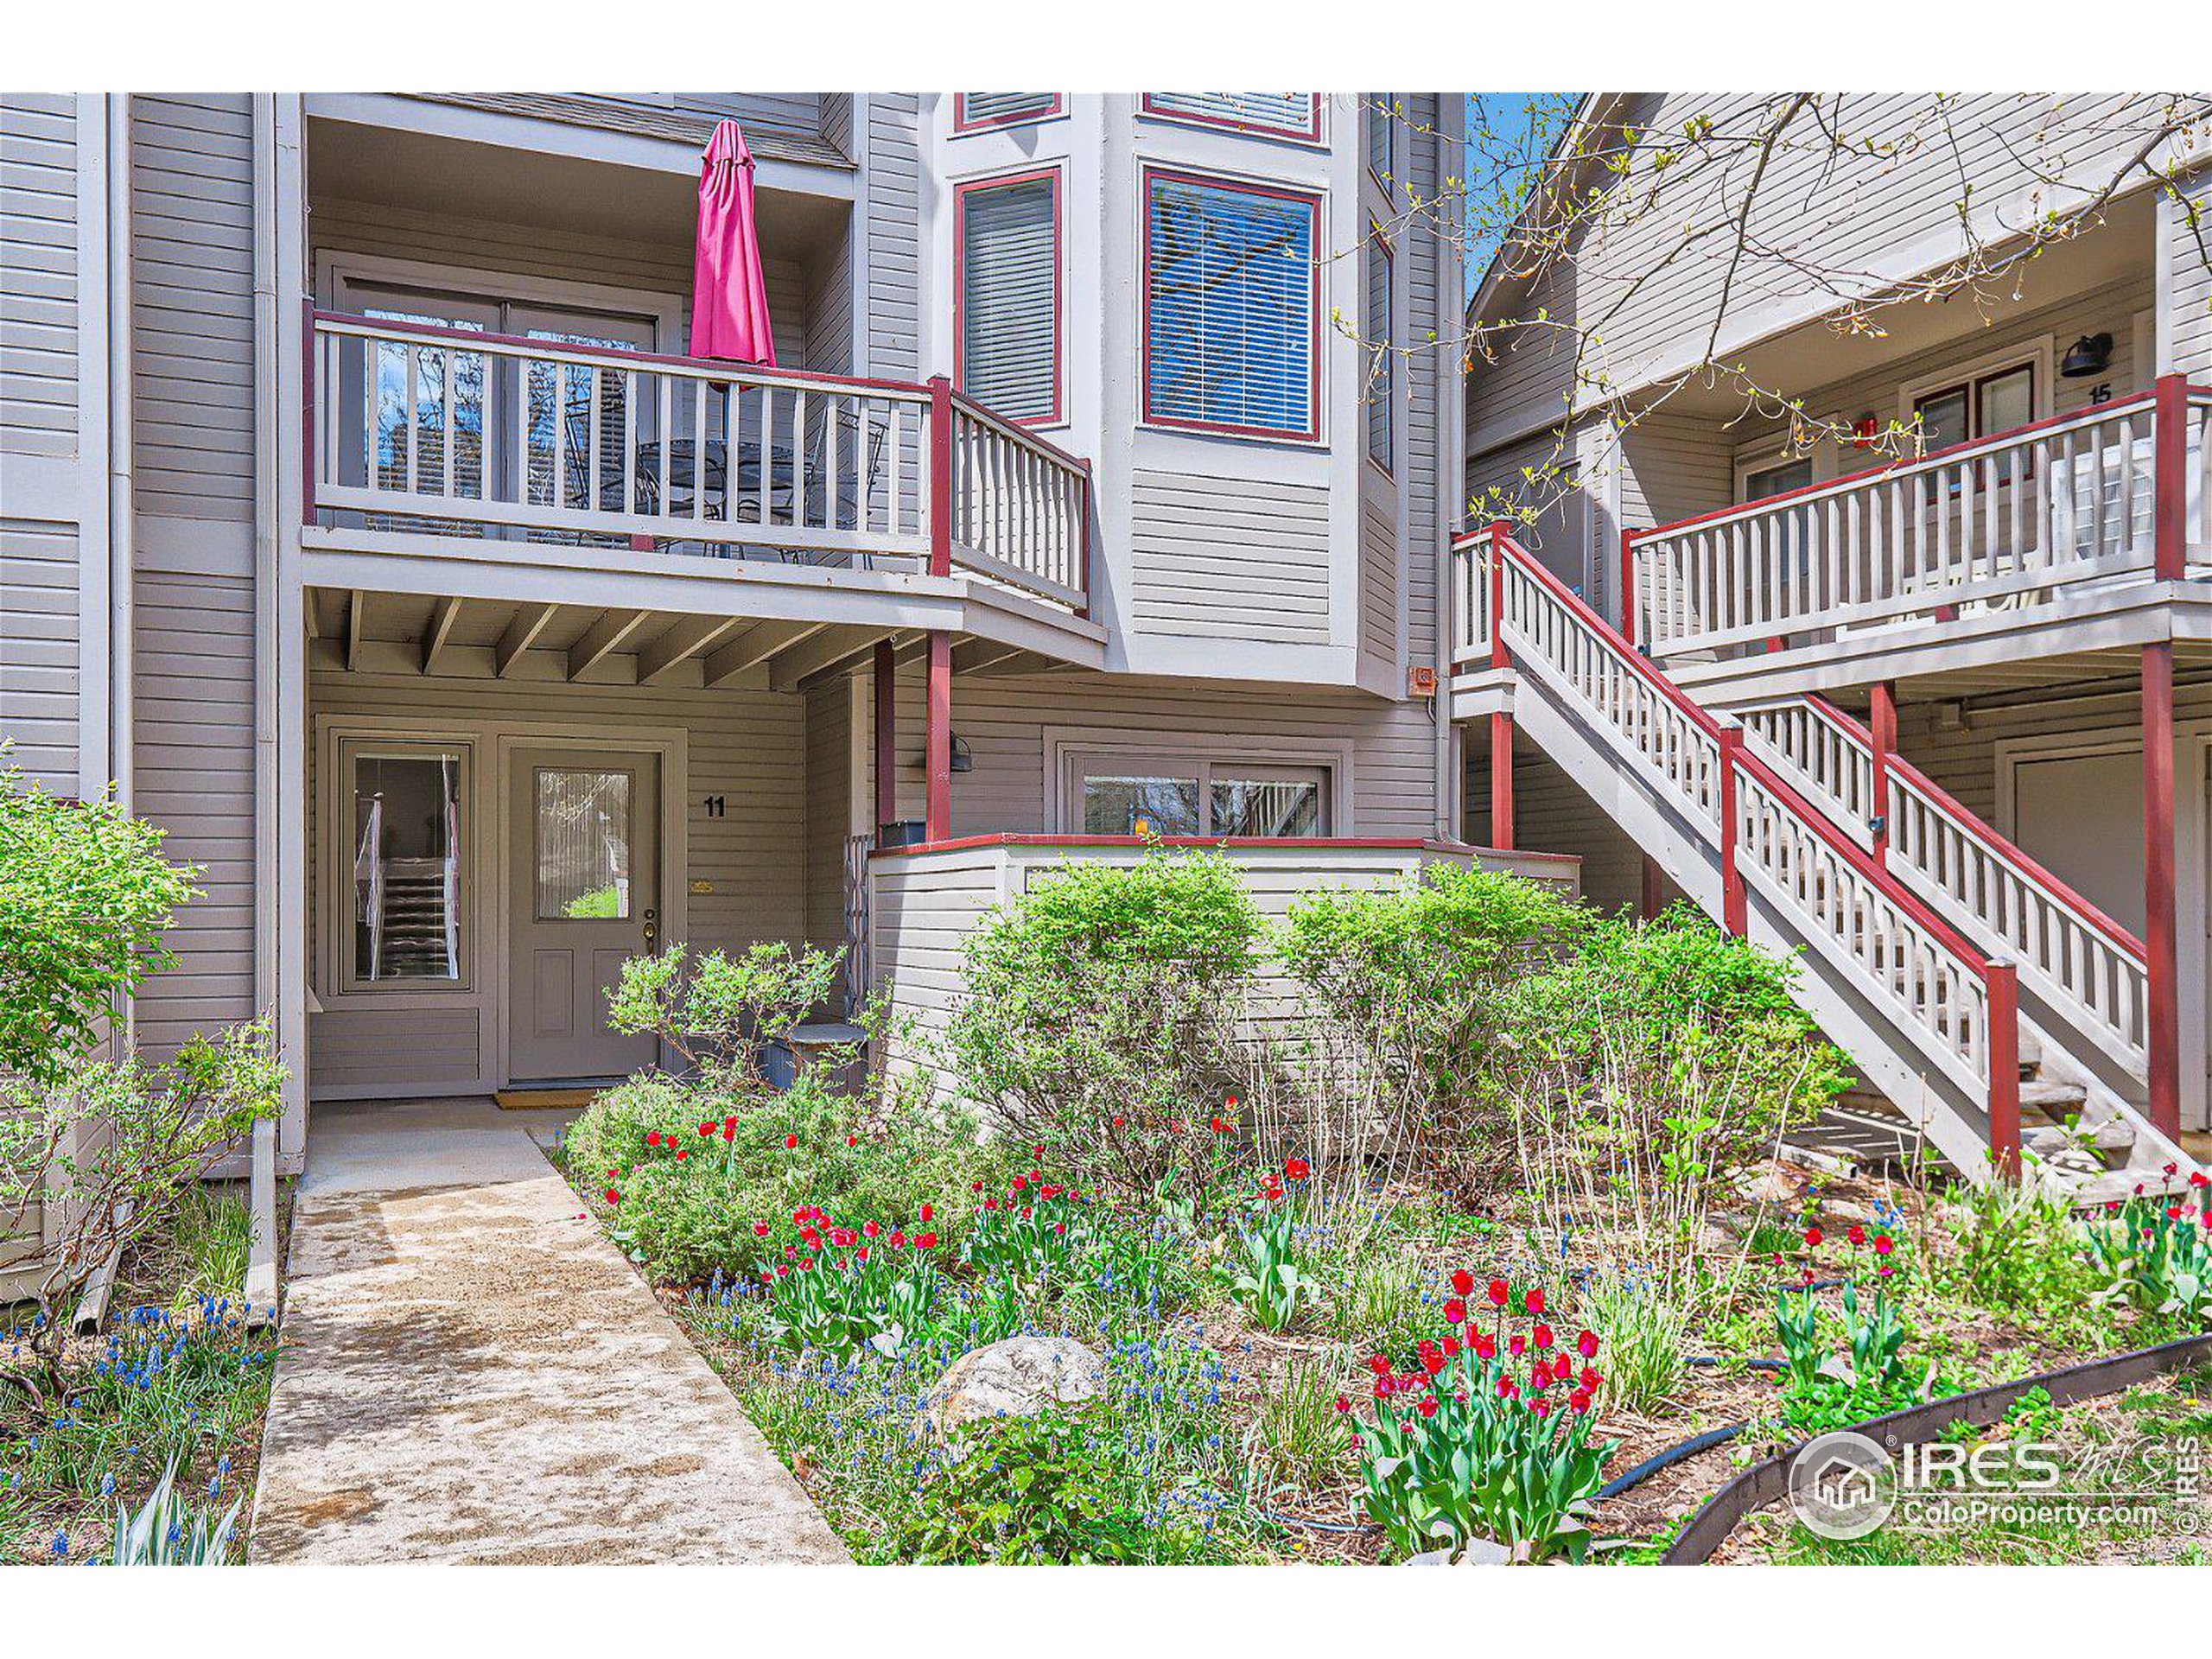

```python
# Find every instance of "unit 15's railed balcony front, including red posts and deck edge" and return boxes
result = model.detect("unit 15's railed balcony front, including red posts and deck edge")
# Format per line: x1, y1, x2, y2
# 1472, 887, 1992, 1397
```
1621, 376, 2212, 683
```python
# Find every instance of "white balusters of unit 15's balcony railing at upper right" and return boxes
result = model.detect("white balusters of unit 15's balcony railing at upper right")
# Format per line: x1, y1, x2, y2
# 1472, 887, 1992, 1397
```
1626, 380, 2212, 659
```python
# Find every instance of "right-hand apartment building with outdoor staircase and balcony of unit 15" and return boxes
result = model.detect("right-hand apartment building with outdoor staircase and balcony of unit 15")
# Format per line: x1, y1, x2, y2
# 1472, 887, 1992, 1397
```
1449, 93, 2212, 1197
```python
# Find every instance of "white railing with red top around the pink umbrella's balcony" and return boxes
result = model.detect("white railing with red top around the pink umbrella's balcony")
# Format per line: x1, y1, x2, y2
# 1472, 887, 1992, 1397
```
305, 312, 1090, 611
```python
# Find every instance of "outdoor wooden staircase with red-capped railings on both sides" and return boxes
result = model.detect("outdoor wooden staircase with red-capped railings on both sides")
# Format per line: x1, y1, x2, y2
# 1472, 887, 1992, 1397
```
1455, 531, 2195, 1204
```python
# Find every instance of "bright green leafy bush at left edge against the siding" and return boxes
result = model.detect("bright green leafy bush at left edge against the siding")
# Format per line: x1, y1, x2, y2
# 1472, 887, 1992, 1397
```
0, 766, 197, 1084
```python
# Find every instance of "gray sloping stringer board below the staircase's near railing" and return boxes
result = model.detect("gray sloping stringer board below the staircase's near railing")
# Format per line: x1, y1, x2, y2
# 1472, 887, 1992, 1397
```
1513, 652, 1991, 1181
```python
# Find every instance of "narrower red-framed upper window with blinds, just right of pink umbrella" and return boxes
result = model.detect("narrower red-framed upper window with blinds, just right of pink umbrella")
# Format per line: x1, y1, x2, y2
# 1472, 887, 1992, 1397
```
953, 170, 1059, 423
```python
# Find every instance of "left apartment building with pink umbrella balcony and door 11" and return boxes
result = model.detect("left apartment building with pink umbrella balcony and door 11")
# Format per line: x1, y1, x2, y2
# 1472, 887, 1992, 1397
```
0, 93, 1462, 1168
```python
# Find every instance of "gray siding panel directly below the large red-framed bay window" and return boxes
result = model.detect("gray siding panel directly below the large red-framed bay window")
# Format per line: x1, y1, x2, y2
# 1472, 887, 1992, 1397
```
1130, 469, 1330, 644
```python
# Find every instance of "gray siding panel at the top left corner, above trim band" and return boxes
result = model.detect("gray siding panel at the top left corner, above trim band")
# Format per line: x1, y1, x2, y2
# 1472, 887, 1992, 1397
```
0, 93, 78, 455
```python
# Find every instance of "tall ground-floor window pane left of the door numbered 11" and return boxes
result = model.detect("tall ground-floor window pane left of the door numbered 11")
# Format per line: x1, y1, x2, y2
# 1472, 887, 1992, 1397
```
349, 752, 465, 984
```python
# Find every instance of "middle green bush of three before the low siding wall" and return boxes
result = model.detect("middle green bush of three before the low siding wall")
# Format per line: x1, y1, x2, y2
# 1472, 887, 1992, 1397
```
1283, 865, 1592, 1185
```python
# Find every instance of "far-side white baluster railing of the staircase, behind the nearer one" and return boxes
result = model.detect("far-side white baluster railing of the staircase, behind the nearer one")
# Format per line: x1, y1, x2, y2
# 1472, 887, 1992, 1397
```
1743, 696, 2150, 1077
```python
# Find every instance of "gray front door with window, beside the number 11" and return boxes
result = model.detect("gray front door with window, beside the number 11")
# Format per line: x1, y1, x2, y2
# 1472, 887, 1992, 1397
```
506, 747, 661, 1084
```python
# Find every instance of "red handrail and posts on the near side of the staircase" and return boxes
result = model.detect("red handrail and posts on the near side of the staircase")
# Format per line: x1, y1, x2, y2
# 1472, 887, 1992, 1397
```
1455, 524, 2019, 1177
